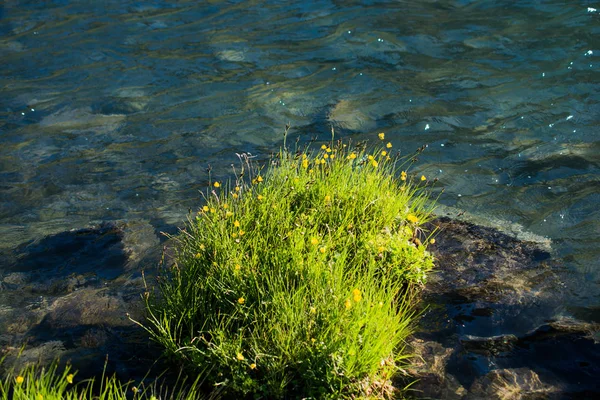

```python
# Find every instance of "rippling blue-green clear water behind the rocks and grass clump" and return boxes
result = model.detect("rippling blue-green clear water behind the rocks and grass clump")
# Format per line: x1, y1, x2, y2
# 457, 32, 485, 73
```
0, 1, 600, 390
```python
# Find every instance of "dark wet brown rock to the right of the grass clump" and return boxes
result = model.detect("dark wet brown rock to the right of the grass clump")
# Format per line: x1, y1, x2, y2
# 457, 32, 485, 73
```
410, 218, 600, 399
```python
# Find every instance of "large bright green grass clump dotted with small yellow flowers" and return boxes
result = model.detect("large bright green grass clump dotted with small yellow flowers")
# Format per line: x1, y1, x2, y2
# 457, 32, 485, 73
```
146, 135, 433, 399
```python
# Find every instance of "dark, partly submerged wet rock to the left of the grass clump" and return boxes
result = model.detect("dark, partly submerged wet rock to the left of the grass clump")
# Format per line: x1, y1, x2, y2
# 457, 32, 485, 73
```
0, 222, 161, 381
